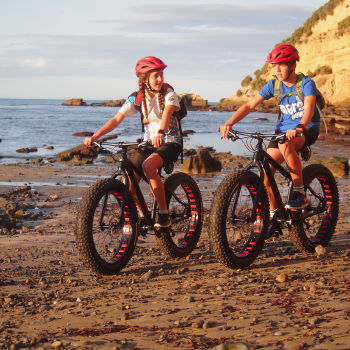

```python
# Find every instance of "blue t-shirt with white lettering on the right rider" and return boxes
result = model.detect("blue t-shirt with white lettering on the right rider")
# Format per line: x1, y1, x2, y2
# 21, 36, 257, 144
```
259, 76, 320, 133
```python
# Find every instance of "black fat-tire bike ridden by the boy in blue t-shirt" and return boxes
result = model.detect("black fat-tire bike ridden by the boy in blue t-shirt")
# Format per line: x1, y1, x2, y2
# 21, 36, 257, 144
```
209, 130, 339, 269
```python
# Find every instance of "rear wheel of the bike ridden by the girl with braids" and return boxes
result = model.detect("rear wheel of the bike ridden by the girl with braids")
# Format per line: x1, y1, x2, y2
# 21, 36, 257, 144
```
157, 172, 203, 258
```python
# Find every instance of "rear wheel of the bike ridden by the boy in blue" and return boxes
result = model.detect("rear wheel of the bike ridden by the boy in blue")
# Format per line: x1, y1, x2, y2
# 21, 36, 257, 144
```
290, 164, 339, 253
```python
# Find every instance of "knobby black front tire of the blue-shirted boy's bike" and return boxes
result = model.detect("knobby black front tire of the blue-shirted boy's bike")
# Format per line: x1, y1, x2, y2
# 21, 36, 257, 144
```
209, 170, 269, 269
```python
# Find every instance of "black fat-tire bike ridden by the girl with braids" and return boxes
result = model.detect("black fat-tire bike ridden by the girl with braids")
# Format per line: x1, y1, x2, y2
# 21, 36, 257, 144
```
75, 142, 203, 275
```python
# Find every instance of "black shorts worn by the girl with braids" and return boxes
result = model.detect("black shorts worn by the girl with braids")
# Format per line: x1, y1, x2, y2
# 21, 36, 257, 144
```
130, 142, 181, 171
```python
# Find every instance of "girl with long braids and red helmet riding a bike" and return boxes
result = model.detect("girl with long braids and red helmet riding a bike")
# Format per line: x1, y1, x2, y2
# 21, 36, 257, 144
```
84, 56, 181, 228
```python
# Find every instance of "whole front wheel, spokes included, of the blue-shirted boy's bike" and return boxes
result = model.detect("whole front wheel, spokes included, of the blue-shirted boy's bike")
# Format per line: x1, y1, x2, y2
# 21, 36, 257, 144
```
209, 170, 269, 269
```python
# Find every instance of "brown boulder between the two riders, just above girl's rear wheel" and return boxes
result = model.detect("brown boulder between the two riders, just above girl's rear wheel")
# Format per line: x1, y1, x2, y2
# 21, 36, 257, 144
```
181, 150, 221, 174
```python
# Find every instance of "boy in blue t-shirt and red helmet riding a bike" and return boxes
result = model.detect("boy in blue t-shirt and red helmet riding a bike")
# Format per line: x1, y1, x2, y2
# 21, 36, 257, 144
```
220, 45, 320, 236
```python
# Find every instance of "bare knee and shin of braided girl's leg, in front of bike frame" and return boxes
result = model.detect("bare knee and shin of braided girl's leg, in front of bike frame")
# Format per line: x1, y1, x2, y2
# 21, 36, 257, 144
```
142, 153, 168, 211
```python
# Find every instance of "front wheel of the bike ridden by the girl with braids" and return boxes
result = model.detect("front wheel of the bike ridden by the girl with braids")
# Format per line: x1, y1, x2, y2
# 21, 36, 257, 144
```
75, 179, 138, 275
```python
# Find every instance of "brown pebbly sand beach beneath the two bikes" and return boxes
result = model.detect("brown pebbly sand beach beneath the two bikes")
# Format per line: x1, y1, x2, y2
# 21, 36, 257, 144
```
0, 137, 350, 350
